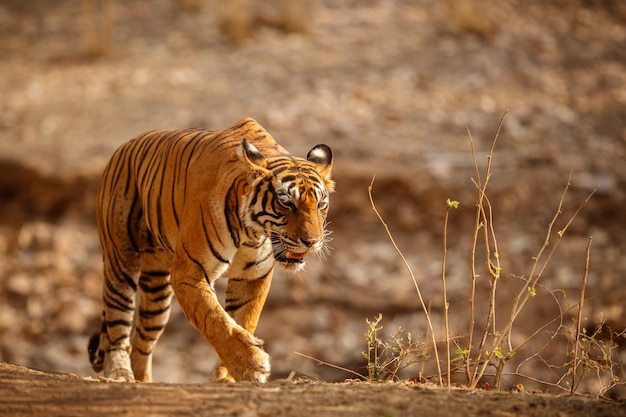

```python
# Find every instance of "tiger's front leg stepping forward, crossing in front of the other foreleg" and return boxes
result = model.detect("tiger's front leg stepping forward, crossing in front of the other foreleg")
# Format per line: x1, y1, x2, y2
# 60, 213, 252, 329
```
171, 252, 270, 382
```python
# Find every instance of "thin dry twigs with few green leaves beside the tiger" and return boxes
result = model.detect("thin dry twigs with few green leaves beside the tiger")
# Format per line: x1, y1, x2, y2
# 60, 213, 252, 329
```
364, 112, 624, 396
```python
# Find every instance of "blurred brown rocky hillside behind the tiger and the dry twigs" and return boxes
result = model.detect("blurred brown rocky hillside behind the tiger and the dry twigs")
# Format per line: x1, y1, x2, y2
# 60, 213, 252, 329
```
0, 0, 626, 394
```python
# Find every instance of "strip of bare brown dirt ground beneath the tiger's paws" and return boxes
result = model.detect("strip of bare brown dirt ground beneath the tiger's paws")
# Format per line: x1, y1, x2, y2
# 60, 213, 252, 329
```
0, 364, 624, 417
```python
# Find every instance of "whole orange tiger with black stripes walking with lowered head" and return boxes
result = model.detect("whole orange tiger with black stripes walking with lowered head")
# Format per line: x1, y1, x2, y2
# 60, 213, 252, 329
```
88, 117, 335, 382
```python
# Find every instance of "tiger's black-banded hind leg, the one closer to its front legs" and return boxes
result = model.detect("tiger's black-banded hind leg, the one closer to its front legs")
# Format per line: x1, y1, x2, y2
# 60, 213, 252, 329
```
130, 249, 173, 382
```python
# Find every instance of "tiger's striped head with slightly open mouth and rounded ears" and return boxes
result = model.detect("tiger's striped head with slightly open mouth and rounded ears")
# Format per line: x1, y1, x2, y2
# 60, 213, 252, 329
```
240, 139, 335, 272
